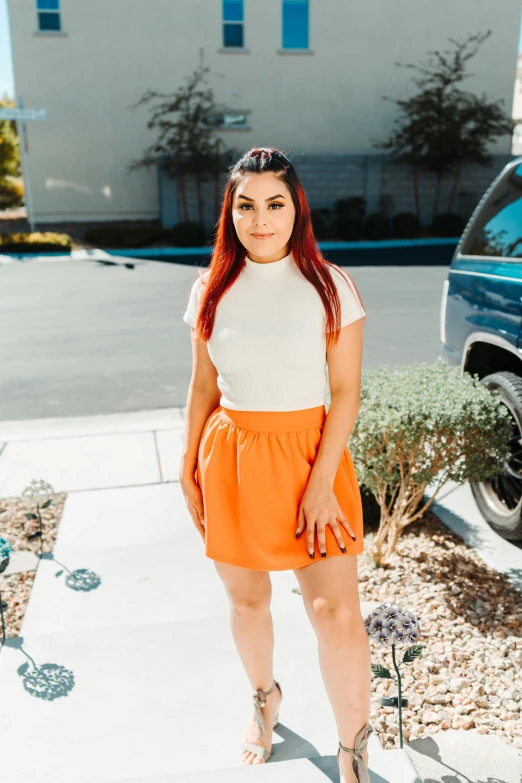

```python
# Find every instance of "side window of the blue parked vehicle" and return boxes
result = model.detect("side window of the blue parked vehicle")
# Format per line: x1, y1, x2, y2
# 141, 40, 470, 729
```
460, 164, 522, 258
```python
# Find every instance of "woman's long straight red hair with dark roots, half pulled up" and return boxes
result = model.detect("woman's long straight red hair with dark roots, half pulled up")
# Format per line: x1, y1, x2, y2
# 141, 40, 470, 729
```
189, 147, 366, 348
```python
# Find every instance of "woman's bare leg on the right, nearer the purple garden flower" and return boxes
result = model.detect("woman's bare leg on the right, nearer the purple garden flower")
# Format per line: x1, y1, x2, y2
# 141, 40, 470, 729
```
294, 555, 371, 783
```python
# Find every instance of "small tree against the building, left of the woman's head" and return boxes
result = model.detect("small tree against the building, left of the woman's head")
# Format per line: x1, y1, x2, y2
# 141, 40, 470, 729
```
129, 64, 234, 223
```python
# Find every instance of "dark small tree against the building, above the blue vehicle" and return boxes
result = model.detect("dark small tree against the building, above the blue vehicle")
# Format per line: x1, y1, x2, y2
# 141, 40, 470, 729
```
374, 30, 517, 219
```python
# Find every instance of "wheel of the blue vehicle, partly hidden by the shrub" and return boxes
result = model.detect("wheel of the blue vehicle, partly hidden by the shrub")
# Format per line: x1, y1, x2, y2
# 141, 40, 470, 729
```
469, 371, 522, 541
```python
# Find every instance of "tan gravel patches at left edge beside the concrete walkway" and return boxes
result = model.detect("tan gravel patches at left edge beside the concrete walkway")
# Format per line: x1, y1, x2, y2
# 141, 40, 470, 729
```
0, 493, 66, 641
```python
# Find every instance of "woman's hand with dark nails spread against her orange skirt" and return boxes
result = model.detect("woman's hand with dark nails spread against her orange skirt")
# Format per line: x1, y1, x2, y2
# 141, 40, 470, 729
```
296, 476, 355, 557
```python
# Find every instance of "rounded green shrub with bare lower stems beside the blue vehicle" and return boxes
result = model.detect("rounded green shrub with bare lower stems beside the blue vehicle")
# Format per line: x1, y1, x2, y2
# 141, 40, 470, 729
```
348, 359, 512, 565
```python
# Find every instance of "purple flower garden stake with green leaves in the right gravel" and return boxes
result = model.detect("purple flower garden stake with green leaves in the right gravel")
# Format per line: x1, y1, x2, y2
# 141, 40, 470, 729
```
364, 601, 426, 748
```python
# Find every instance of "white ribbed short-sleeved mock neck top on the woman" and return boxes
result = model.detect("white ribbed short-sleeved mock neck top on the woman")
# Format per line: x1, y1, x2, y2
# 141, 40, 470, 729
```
183, 253, 365, 411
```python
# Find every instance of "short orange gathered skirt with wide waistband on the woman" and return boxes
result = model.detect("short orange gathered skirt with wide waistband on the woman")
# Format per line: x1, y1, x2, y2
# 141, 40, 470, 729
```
196, 405, 364, 571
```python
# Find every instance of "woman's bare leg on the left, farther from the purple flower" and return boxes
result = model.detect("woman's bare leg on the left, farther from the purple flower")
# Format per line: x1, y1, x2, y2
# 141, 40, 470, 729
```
214, 560, 281, 764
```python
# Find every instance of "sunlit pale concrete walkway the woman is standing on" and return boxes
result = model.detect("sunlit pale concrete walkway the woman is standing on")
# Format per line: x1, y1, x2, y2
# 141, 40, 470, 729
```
0, 408, 522, 783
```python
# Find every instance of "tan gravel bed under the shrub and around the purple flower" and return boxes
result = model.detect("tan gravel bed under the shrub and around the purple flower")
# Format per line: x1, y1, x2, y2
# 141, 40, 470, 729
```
359, 510, 522, 748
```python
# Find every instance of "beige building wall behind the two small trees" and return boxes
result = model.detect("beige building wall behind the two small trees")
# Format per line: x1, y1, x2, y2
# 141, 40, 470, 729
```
8, 0, 520, 221
